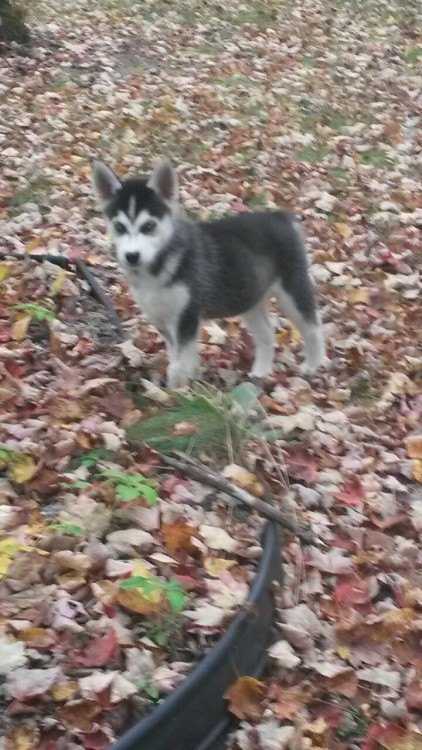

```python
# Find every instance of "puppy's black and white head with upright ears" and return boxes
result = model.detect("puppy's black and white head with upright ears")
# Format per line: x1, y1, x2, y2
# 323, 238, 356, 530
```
92, 159, 178, 270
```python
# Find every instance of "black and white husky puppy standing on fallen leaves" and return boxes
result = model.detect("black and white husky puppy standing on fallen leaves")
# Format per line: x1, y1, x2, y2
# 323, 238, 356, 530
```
93, 159, 325, 388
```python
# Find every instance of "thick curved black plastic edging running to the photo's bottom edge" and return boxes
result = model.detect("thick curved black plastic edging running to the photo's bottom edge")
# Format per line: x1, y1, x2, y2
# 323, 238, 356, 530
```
110, 522, 281, 750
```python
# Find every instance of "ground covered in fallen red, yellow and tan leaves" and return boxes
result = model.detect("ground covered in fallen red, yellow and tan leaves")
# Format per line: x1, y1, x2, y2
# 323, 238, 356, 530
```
0, 0, 422, 750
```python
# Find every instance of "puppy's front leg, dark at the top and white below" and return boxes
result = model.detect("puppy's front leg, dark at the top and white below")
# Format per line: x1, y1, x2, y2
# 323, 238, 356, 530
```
167, 309, 199, 388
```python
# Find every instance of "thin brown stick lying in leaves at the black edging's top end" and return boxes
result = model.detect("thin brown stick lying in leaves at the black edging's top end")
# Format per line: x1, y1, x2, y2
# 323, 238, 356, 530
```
160, 454, 315, 544
